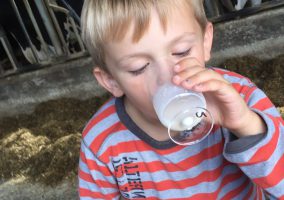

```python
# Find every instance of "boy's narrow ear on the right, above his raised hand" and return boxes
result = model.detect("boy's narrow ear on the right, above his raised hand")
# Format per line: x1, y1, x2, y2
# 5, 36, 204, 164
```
203, 22, 213, 62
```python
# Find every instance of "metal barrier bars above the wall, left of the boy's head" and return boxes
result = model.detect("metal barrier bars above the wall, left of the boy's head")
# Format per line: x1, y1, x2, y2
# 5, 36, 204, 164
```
0, 0, 87, 77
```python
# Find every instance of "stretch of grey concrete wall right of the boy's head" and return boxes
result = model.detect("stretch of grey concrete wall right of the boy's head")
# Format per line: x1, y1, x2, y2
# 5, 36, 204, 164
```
210, 7, 284, 65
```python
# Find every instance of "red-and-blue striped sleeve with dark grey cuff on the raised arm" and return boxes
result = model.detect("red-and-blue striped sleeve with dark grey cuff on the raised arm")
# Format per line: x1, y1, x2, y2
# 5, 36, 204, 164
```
224, 87, 284, 199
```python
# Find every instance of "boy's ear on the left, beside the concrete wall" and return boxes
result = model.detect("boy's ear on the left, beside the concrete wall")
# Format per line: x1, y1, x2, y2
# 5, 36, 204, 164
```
93, 67, 123, 97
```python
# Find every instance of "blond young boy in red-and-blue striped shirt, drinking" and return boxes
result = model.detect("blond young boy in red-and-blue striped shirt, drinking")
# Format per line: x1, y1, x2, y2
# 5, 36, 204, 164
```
79, 0, 284, 199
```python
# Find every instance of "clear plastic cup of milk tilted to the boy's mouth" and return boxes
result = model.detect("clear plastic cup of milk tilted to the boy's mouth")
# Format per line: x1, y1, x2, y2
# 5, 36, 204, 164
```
153, 83, 213, 145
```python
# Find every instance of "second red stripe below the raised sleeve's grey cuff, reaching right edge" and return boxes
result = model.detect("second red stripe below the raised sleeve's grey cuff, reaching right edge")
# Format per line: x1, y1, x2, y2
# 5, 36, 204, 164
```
253, 155, 284, 188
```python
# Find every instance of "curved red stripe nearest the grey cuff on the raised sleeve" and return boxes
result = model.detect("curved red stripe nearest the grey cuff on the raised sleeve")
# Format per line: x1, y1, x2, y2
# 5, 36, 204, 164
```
239, 117, 279, 166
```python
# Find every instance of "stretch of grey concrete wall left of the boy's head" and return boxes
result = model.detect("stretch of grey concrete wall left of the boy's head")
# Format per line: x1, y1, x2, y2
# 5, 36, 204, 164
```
0, 57, 104, 117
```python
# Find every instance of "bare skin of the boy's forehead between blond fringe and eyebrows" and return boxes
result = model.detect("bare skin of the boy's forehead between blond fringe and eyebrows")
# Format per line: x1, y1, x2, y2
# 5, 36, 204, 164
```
104, 5, 202, 63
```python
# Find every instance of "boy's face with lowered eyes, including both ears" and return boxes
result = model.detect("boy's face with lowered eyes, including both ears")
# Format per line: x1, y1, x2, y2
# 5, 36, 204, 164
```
94, 5, 212, 124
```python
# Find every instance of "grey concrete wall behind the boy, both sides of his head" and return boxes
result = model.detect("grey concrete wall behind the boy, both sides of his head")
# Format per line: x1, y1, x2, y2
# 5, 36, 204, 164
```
0, 7, 284, 117
